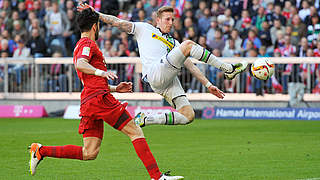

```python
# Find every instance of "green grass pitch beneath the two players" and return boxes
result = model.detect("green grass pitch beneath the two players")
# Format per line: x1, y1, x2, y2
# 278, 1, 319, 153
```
0, 118, 320, 180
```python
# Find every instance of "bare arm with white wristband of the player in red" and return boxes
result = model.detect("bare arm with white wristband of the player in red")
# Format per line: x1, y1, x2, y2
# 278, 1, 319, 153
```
75, 58, 118, 79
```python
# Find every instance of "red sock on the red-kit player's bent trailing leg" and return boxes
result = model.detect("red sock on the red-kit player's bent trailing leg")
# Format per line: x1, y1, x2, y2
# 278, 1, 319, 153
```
40, 145, 83, 160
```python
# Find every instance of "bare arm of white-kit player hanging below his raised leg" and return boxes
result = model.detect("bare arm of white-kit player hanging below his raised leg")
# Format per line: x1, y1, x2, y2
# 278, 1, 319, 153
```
184, 58, 225, 99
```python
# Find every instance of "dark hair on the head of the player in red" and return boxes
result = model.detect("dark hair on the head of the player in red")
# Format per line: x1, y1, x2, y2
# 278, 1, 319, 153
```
77, 8, 99, 32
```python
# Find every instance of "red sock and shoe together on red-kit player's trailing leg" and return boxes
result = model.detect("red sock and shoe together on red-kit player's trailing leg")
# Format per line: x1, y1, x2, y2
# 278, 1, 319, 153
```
29, 143, 83, 175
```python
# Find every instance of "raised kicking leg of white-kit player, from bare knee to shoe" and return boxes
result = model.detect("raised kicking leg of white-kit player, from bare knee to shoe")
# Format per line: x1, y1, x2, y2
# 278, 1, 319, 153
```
180, 40, 248, 79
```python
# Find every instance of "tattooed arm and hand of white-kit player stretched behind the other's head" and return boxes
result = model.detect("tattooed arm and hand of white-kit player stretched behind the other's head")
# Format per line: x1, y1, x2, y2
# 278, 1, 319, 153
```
78, 3, 134, 34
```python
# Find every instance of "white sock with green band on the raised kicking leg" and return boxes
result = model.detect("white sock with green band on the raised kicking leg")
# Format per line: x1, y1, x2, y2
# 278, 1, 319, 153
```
190, 44, 233, 73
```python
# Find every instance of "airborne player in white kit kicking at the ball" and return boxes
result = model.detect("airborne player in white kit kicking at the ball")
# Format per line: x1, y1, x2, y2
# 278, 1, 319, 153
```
80, 4, 248, 127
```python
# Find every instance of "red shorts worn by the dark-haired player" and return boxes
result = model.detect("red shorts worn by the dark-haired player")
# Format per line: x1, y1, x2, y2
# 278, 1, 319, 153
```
79, 93, 132, 139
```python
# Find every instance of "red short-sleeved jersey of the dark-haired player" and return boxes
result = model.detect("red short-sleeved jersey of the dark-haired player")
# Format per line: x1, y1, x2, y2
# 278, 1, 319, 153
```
73, 37, 110, 102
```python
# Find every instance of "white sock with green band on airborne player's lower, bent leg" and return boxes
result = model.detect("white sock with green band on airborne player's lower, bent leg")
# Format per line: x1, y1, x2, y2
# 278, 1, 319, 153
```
144, 112, 189, 125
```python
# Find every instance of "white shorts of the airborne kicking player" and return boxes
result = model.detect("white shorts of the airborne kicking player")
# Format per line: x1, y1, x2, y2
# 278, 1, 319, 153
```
147, 47, 190, 108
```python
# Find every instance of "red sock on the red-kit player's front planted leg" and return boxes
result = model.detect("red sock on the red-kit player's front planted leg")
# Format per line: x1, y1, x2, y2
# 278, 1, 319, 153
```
132, 138, 161, 179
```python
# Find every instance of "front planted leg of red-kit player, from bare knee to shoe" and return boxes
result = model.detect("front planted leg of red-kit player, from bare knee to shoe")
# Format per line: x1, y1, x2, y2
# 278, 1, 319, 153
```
121, 120, 183, 180
